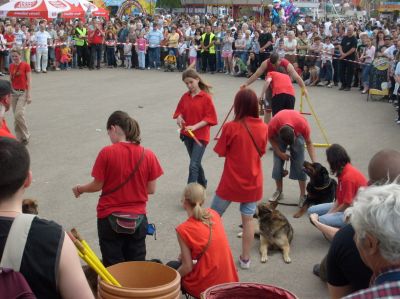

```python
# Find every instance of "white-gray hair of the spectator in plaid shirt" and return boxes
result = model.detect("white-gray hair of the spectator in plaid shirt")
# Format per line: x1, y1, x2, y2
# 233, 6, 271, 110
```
345, 180, 400, 263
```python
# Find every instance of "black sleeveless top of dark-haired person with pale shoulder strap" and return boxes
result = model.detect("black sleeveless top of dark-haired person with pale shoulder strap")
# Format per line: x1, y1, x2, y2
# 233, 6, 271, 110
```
0, 217, 64, 299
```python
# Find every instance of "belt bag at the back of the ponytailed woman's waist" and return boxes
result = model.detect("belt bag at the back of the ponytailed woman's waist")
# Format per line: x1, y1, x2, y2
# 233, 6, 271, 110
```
108, 212, 144, 235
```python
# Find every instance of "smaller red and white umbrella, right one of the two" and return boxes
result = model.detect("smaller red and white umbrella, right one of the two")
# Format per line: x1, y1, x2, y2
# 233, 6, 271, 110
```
62, 0, 109, 19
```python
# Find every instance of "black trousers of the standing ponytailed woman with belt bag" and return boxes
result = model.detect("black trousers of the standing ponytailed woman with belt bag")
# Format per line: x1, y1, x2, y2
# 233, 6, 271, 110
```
97, 216, 147, 267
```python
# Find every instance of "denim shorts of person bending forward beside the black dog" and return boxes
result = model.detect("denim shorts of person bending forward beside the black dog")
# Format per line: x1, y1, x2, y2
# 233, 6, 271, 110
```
272, 135, 307, 181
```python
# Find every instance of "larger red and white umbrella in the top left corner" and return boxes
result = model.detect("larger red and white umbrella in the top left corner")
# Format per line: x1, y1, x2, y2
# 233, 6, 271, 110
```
0, 0, 71, 19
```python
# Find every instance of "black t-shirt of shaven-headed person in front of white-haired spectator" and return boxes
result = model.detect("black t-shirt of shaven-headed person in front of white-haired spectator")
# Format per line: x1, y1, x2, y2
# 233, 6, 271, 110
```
327, 224, 372, 291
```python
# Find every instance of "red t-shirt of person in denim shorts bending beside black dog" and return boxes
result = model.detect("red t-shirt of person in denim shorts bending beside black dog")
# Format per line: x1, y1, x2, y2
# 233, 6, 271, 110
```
268, 109, 311, 141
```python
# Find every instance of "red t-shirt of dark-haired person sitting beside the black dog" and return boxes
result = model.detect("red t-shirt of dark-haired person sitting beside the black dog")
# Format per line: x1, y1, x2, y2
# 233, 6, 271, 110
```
336, 163, 368, 205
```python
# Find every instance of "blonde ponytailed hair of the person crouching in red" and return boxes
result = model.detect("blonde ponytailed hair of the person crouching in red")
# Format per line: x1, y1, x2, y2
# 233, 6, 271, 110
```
182, 183, 211, 225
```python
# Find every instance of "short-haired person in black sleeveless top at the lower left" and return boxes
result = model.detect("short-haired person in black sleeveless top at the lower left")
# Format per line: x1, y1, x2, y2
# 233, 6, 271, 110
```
0, 138, 93, 299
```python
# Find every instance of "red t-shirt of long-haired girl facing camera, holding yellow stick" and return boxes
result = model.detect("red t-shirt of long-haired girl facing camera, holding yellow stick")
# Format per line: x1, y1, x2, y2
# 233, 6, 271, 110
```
173, 91, 218, 143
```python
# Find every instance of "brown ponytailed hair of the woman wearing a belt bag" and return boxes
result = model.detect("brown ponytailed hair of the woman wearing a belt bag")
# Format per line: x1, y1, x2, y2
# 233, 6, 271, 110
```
107, 111, 141, 144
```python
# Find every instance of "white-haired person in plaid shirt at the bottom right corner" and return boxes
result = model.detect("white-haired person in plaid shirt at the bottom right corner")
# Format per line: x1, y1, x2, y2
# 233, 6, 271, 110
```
345, 182, 400, 299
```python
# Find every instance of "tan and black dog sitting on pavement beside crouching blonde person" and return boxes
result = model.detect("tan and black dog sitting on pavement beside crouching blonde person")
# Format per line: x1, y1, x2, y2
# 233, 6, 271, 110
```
257, 203, 293, 263
